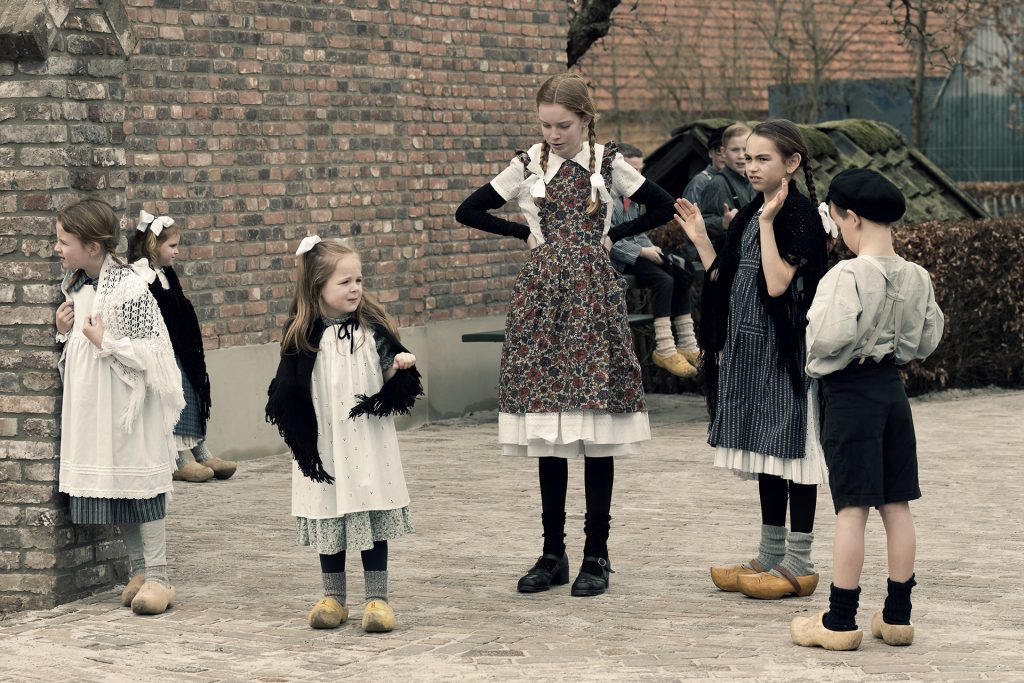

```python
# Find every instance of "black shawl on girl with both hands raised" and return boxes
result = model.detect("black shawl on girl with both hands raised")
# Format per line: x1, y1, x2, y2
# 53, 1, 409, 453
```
698, 180, 827, 420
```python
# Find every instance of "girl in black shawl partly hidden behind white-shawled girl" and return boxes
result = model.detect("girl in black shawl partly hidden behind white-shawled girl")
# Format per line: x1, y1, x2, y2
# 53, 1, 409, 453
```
128, 211, 238, 482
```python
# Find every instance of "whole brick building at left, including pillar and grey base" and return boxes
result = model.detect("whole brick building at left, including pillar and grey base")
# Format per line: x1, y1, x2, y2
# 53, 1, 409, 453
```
0, 0, 565, 611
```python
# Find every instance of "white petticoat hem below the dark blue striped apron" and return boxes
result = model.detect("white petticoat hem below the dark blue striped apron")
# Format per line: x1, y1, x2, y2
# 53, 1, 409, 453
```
715, 382, 828, 484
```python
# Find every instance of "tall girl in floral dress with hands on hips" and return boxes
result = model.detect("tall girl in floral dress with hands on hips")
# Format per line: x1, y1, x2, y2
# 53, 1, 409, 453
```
456, 74, 672, 596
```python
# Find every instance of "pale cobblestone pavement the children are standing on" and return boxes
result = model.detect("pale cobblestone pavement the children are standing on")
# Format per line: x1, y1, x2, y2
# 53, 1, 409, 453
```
0, 391, 1024, 683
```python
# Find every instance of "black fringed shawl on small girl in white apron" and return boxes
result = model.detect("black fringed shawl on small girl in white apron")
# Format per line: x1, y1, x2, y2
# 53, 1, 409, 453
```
266, 318, 423, 483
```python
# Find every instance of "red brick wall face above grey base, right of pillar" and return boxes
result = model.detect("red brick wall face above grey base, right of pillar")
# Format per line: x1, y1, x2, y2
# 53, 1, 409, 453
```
125, 0, 565, 348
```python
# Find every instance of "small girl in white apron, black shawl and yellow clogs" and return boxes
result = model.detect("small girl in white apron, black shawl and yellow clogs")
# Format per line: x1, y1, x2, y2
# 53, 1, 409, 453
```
266, 236, 423, 632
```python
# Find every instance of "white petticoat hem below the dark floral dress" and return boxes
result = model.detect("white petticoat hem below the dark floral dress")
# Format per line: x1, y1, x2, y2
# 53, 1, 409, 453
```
498, 411, 650, 458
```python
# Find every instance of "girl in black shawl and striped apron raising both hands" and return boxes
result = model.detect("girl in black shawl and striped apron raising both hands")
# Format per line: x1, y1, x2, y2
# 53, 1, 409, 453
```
676, 119, 827, 599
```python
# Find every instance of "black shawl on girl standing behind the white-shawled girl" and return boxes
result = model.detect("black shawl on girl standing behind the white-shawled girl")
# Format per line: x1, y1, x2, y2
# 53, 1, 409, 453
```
150, 266, 213, 434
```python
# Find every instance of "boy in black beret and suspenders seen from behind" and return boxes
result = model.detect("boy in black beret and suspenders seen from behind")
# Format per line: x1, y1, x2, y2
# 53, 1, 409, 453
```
790, 169, 944, 650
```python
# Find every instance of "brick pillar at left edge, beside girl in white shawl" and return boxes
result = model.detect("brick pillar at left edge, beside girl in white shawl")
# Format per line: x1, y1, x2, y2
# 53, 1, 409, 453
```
0, 0, 134, 612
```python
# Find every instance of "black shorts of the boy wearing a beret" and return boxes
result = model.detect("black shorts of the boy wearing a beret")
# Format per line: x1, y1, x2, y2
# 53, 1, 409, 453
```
821, 359, 921, 512
